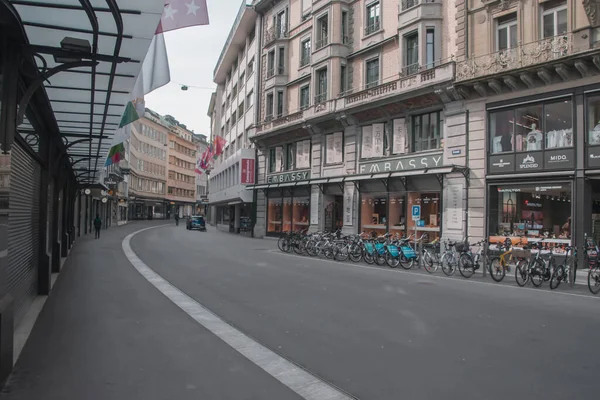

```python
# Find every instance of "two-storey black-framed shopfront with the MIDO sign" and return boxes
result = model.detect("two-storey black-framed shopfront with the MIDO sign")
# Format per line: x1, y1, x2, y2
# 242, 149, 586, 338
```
486, 86, 600, 245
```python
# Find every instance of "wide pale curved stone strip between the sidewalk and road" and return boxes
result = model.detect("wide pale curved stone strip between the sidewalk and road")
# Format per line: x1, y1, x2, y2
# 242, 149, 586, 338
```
122, 225, 354, 400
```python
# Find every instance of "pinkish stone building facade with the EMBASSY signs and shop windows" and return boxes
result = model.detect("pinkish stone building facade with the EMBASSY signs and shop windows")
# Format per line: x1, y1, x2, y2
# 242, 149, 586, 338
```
248, 0, 468, 240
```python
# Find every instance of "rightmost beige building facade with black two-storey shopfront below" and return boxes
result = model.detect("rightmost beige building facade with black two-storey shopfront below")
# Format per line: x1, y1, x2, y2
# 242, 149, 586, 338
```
454, 0, 600, 245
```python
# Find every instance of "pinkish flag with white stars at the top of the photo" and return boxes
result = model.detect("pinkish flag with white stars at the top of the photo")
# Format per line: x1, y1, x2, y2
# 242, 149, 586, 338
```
156, 0, 208, 34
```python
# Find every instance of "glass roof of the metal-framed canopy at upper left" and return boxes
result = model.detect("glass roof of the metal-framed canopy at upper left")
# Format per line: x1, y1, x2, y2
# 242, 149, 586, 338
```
9, 0, 164, 184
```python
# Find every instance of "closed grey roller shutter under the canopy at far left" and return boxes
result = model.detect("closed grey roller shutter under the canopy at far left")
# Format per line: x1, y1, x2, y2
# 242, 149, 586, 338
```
7, 143, 41, 325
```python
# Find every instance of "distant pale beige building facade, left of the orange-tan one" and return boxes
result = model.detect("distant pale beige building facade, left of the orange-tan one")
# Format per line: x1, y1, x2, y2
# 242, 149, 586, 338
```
126, 109, 169, 220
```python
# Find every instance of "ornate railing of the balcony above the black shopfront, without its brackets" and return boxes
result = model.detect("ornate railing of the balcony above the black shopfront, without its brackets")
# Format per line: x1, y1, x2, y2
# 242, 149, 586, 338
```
456, 33, 574, 81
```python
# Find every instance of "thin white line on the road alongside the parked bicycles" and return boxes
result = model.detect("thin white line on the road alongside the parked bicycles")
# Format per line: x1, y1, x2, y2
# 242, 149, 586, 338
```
268, 250, 600, 300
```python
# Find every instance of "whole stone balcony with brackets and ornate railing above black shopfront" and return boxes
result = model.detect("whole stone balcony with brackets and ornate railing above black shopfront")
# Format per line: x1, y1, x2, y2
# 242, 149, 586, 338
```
456, 32, 600, 97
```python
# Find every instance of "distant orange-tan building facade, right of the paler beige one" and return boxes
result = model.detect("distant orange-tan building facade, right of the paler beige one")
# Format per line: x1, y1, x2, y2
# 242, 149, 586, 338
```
166, 124, 196, 218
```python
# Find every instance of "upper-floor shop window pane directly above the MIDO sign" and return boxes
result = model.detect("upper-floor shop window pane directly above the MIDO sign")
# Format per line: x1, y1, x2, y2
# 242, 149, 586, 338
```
544, 100, 573, 149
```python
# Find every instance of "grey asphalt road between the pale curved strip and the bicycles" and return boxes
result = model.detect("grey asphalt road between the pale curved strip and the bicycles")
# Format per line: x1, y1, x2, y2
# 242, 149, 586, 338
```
131, 224, 600, 400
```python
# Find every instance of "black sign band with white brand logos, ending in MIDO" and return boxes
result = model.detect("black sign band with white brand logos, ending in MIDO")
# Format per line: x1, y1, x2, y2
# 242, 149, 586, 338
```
488, 148, 576, 174
